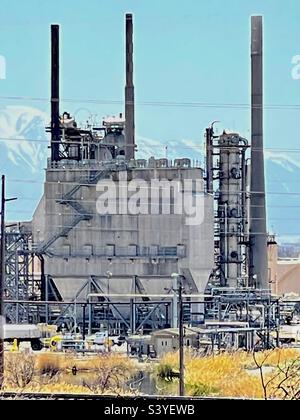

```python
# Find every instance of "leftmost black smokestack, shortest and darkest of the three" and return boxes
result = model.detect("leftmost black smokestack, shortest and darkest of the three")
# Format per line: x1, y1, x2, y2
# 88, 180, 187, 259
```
51, 25, 60, 162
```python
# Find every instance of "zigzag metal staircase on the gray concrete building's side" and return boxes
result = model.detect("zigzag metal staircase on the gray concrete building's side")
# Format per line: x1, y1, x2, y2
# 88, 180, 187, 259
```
37, 163, 116, 257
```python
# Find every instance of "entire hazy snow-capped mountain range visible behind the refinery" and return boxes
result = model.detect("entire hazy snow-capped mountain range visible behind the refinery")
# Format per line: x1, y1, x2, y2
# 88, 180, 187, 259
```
0, 106, 300, 242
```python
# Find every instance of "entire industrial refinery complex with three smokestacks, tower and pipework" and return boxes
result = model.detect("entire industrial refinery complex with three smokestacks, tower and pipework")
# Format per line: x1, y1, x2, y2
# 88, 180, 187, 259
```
0, 7, 300, 400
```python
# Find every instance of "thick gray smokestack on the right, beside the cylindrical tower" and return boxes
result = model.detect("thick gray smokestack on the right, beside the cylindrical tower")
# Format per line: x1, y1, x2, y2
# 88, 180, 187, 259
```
249, 16, 269, 289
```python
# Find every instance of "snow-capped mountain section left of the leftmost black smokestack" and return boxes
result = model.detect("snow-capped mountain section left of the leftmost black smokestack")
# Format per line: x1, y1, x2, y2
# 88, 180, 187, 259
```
0, 106, 48, 221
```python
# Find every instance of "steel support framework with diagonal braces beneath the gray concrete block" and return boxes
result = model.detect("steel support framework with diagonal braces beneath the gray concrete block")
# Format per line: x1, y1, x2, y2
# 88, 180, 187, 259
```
44, 276, 174, 334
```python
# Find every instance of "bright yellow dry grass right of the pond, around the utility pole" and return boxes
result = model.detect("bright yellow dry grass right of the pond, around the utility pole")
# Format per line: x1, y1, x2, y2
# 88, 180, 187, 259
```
158, 349, 300, 398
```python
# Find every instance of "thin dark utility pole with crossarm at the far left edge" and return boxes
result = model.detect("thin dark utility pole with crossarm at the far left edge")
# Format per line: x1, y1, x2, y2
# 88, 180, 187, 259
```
0, 175, 16, 389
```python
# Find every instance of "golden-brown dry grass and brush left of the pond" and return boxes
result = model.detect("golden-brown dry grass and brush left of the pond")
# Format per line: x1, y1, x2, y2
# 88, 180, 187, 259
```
5, 353, 135, 395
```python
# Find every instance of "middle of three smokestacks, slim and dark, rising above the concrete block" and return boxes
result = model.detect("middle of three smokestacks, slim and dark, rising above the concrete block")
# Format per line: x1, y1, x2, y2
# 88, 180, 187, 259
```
125, 14, 135, 160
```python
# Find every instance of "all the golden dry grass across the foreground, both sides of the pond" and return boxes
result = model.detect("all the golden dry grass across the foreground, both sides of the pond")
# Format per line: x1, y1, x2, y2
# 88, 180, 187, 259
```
5, 349, 300, 399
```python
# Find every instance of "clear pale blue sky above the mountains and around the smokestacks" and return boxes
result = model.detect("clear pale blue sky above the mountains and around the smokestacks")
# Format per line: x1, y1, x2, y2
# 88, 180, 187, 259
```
0, 0, 300, 238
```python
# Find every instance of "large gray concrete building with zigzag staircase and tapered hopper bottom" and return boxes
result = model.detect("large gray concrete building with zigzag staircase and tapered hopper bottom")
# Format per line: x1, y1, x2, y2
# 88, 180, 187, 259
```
33, 154, 214, 328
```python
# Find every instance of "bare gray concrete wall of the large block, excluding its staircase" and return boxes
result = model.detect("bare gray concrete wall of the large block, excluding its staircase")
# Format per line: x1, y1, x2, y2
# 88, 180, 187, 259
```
33, 161, 214, 306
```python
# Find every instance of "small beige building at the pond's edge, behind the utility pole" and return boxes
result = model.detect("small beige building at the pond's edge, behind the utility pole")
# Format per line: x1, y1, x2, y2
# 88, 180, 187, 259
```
151, 328, 198, 357
